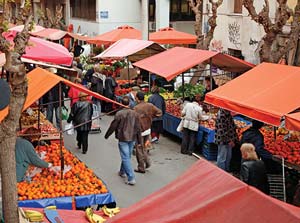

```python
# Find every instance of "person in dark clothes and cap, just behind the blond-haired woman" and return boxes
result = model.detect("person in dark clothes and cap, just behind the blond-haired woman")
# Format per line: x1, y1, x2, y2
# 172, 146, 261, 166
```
241, 120, 277, 173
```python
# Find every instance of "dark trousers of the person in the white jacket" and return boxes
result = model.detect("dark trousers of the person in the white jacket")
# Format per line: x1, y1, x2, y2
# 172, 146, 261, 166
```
181, 128, 198, 154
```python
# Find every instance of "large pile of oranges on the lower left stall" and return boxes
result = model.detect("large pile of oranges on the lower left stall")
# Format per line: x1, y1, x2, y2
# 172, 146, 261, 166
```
18, 144, 108, 200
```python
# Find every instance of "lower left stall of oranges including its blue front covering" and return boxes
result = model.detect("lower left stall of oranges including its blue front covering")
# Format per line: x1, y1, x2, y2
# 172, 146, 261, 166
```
18, 143, 115, 209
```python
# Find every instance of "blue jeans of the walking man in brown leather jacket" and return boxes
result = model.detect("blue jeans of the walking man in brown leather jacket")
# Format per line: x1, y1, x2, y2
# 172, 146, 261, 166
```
118, 141, 135, 181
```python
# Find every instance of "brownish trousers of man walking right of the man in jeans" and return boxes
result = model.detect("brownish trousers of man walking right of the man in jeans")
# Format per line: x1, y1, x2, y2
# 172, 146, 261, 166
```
136, 135, 150, 172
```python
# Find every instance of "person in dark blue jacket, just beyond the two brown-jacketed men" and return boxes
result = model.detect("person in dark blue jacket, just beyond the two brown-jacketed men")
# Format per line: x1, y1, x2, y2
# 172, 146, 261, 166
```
148, 86, 166, 142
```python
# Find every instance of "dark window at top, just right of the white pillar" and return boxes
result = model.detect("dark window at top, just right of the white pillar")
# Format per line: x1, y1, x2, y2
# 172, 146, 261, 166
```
170, 0, 197, 21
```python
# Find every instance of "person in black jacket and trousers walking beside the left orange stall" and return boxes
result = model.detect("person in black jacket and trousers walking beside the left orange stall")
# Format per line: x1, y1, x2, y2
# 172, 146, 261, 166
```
67, 92, 93, 154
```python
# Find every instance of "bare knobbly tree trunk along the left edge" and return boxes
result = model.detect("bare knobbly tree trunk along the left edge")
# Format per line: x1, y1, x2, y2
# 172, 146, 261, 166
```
0, 7, 32, 220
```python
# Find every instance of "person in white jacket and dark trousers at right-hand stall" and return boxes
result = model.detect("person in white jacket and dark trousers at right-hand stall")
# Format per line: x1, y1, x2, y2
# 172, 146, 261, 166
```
181, 97, 203, 155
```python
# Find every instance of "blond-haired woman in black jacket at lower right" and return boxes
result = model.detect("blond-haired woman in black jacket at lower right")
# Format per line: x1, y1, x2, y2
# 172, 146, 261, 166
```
240, 143, 269, 194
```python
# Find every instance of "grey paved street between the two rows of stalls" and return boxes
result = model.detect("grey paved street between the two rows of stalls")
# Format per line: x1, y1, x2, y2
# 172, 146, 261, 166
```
64, 116, 197, 207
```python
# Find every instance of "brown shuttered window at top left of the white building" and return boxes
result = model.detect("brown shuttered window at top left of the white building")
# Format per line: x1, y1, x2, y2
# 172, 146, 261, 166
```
70, 0, 96, 21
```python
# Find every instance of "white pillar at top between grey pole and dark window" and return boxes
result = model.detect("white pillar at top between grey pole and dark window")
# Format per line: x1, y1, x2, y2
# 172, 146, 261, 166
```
155, 0, 170, 31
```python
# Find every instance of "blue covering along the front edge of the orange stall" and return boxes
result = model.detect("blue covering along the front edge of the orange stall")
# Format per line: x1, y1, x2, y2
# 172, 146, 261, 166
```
18, 192, 115, 210
